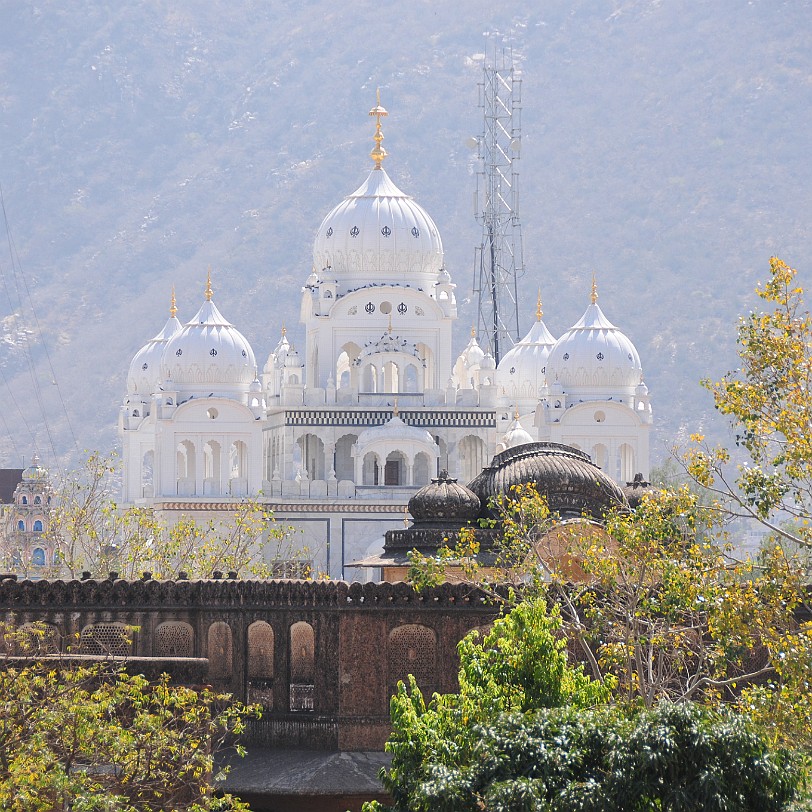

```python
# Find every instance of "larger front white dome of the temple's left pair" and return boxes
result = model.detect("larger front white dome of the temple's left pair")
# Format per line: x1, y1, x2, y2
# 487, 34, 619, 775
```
161, 299, 257, 393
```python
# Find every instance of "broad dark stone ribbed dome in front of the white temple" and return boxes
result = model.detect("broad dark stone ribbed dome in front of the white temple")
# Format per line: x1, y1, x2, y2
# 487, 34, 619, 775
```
468, 443, 626, 520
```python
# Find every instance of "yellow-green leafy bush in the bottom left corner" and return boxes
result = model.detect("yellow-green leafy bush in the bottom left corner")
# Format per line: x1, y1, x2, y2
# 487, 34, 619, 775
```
0, 635, 253, 812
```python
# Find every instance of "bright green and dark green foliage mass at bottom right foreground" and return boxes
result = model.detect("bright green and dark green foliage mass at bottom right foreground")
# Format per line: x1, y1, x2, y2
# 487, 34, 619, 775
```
365, 600, 800, 812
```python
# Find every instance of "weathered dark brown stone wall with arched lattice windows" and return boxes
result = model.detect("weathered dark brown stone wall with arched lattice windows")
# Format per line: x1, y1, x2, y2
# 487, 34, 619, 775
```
0, 578, 495, 750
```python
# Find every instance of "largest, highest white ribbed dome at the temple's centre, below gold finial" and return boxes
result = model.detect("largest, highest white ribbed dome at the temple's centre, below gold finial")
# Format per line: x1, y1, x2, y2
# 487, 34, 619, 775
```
313, 168, 443, 286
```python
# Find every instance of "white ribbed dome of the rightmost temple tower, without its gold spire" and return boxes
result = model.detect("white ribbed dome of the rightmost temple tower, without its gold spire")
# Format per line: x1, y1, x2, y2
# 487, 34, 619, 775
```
547, 301, 643, 396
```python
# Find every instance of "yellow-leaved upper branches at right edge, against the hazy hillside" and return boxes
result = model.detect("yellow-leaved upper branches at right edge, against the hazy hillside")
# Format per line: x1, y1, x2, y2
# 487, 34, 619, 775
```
686, 257, 812, 547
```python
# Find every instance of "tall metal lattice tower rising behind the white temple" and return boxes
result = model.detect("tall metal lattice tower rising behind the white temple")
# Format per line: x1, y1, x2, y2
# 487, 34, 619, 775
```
474, 48, 524, 364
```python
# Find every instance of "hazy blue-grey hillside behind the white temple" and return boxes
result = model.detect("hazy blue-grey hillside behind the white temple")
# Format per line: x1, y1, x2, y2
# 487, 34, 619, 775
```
0, 0, 812, 466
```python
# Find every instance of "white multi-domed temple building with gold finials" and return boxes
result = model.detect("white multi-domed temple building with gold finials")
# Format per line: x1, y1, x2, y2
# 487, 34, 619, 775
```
119, 98, 652, 580
